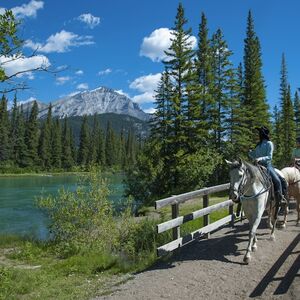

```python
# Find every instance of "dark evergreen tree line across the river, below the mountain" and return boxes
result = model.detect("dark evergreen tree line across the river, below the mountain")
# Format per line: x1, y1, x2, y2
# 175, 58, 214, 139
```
0, 95, 141, 172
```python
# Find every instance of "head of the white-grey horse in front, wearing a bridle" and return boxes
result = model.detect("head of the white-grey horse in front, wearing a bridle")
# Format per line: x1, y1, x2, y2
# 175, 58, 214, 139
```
225, 158, 245, 202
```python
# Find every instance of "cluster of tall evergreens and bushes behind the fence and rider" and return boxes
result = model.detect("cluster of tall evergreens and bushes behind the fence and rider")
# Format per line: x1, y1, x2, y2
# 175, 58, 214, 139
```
127, 4, 300, 204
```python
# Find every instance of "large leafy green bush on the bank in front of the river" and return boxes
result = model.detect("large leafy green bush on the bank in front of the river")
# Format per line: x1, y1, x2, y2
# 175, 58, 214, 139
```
38, 171, 115, 256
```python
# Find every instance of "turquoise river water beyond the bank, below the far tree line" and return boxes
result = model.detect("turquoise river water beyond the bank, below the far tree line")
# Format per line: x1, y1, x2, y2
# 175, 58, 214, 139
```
0, 175, 124, 239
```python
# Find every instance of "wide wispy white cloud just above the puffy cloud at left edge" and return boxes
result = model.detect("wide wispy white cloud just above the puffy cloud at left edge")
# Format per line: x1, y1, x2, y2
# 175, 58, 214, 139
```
25, 30, 94, 53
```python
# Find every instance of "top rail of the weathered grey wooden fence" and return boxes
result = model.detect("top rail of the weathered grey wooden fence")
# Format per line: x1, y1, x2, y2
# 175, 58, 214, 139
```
155, 183, 229, 209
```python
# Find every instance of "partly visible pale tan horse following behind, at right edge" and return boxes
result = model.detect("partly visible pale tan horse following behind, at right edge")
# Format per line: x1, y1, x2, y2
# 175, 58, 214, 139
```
281, 166, 300, 228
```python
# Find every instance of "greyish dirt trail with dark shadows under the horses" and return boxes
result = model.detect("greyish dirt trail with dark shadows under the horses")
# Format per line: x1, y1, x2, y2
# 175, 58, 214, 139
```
96, 205, 300, 300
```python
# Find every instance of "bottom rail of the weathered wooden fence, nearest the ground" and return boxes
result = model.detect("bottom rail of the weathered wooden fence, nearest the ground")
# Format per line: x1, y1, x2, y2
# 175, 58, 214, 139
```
157, 216, 231, 256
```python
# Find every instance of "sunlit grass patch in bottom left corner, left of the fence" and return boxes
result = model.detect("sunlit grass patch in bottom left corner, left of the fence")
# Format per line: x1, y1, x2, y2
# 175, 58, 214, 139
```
0, 236, 145, 299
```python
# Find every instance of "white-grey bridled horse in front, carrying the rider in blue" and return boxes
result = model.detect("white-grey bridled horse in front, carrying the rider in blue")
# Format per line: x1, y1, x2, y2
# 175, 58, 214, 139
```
226, 159, 279, 264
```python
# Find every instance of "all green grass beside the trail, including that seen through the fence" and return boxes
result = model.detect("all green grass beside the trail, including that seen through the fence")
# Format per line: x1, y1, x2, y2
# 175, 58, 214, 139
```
0, 191, 232, 299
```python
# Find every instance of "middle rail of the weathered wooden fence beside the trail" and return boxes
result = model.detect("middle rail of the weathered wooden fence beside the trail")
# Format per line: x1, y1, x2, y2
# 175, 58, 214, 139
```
156, 200, 233, 233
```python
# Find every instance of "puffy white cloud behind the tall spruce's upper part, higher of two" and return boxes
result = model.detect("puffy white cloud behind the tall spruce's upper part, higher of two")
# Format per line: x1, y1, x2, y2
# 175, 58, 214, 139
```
140, 28, 197, 62
